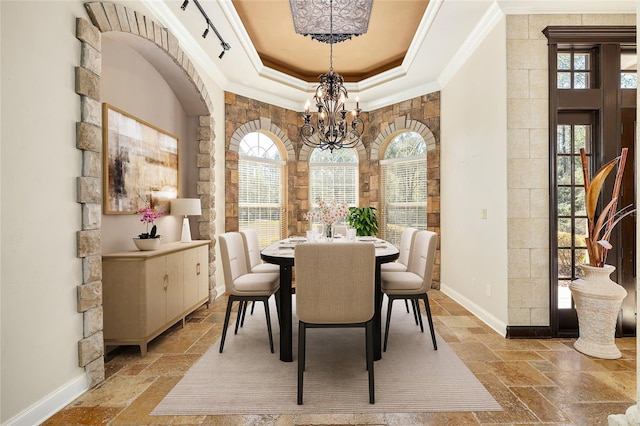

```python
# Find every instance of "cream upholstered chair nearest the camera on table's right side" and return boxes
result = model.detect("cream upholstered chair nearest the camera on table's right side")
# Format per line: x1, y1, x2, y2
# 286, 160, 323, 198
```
380, 231, 438, 351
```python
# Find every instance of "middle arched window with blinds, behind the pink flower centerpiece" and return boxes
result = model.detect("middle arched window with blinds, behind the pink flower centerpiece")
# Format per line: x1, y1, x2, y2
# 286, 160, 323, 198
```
309, 148, 358, 208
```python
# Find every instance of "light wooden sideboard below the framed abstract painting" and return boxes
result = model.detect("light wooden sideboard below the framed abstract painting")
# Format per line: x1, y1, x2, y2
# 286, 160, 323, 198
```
102, 240, 211, 356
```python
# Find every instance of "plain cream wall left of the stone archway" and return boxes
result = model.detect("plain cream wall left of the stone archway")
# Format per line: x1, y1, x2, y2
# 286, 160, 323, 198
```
0, 1, 86, 424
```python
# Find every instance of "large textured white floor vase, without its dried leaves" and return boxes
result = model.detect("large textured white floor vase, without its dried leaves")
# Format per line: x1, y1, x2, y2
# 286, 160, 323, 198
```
569, 265, 627, 359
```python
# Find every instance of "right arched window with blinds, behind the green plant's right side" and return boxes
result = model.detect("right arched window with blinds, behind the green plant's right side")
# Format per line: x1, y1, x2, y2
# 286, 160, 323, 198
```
380, 132, 427, 246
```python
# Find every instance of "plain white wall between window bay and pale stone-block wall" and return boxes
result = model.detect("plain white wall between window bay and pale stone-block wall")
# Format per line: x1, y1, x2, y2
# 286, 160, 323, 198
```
440, 18, 508, 335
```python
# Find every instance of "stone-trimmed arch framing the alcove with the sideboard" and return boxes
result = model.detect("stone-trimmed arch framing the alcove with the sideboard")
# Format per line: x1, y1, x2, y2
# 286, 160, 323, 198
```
75, 2, 217, 387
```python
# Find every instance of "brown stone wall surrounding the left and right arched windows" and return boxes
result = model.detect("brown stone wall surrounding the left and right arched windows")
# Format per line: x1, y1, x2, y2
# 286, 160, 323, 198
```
225, 92, 440, 288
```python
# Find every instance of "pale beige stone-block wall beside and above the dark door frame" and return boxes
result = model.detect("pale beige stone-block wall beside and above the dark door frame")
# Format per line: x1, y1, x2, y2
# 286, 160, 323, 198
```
507, 15, 636, 326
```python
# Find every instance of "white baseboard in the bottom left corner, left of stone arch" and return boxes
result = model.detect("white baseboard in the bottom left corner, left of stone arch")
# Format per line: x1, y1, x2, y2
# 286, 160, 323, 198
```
3, 373, 88, 426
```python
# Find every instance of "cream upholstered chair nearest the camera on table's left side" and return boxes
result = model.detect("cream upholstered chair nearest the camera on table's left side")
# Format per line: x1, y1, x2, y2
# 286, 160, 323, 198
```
220, 232, 280, 353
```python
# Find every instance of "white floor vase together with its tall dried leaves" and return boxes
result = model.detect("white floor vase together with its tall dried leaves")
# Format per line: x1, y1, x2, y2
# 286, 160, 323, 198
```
569, 148, 635, 359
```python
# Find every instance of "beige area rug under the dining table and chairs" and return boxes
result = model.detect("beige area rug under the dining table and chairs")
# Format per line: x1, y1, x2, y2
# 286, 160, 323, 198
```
151, 298, 502, 415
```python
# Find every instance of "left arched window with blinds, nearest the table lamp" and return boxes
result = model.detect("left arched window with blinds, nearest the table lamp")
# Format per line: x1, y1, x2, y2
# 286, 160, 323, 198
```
238, 132, 285, 247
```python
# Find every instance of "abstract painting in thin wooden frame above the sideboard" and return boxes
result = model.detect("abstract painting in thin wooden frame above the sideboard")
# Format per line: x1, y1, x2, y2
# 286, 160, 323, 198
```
102, 103, 178, 214
